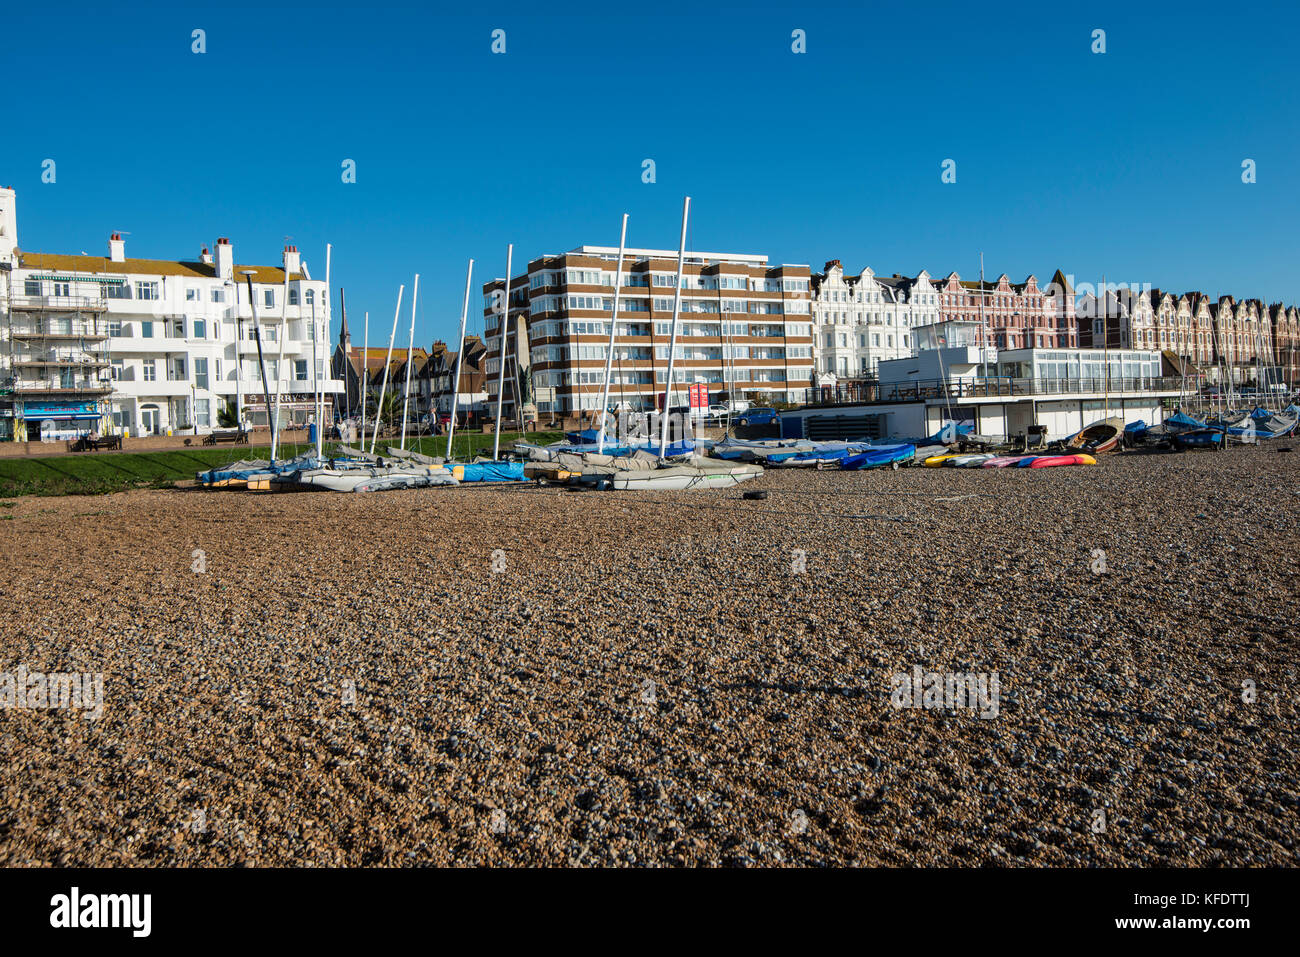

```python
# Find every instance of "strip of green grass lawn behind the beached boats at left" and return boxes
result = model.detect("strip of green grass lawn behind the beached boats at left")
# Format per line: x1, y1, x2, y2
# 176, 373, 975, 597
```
0, 432, 563, 498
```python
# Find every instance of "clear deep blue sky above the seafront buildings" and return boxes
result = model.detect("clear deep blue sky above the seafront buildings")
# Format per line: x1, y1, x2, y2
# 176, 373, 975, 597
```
0, 0, 1300, 345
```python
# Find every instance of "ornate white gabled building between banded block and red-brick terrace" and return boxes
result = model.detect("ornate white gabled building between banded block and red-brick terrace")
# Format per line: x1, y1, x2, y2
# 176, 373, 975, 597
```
813, 259, 939, 386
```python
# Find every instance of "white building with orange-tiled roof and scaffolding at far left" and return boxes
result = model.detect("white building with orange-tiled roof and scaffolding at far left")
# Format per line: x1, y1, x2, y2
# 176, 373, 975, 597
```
0, 190, 343, 441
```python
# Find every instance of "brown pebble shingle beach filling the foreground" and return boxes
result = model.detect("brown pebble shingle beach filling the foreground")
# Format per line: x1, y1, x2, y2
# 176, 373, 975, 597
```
0, 446, 1300, 866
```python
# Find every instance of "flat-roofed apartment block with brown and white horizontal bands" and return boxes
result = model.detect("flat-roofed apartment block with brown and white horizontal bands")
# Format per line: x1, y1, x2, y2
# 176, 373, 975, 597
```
482, 246, 813, 421
